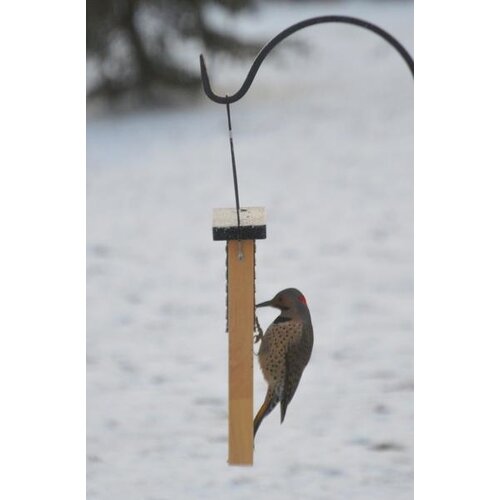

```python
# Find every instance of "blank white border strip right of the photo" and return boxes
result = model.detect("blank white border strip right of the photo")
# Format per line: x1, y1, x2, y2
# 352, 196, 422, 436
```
415, 2, 500, 500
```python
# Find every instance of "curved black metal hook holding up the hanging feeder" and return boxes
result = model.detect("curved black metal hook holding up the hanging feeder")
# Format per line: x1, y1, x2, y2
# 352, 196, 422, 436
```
200, 16, 413, 104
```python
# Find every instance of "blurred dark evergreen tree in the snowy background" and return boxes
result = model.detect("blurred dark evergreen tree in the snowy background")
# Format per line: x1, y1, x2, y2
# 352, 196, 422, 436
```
87, 0, 260, 100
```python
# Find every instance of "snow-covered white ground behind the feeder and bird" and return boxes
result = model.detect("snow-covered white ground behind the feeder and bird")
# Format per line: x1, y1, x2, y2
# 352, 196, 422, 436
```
87, 1, 413, 500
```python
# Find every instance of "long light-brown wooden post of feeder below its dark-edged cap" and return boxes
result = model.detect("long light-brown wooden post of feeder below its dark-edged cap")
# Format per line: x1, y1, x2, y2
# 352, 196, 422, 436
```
227, 240, 255, 465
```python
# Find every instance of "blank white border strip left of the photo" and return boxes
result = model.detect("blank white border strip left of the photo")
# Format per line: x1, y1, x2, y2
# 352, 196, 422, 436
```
0, 1, 85, 499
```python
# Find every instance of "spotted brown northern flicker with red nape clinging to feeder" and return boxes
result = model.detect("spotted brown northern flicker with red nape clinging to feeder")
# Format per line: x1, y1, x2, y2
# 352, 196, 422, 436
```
253, 288, 313, 437
